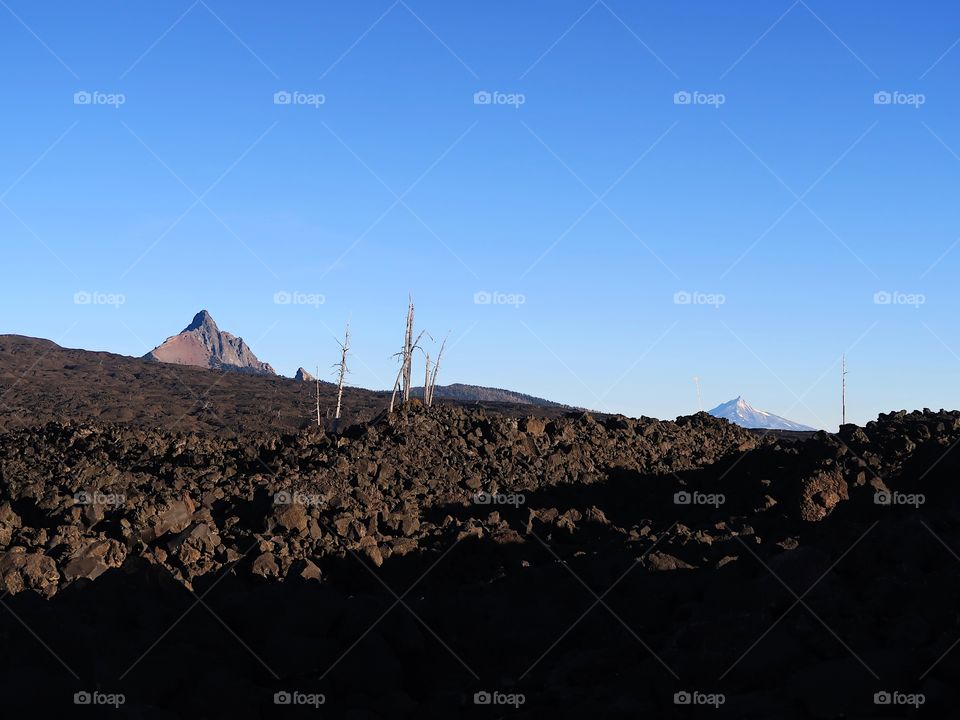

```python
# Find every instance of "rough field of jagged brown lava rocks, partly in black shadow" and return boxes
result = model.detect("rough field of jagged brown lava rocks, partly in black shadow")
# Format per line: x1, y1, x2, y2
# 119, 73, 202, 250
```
0, 406, 960, 718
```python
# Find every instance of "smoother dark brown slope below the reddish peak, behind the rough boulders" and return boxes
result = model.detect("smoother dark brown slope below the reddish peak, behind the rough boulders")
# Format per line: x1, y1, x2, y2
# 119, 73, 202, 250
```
0, 335, 563, 434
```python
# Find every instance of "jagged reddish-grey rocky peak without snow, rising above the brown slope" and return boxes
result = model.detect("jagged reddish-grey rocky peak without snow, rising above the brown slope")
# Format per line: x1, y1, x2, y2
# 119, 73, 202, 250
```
144, 310, 276, 375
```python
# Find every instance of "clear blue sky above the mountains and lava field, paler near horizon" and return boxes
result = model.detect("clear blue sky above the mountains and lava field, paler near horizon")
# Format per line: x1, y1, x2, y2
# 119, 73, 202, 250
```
0, 0, 960, 428
